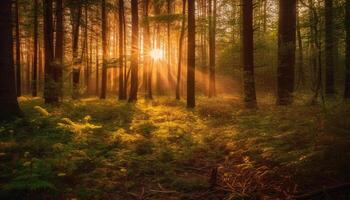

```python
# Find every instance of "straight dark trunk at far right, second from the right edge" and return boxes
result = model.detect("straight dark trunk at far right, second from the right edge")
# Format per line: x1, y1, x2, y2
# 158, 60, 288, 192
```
325, 0, 335, 96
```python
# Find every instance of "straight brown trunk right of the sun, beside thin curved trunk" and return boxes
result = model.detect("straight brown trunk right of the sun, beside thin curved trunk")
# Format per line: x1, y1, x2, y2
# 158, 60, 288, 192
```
187, 0, 196, 108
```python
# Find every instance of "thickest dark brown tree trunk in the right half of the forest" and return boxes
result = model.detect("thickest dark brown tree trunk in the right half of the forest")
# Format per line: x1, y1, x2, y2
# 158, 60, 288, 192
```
277, 0, 296, 105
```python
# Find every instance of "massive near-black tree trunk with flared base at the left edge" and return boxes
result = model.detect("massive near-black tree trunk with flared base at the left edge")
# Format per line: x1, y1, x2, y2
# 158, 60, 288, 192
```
0, 0, 21, 120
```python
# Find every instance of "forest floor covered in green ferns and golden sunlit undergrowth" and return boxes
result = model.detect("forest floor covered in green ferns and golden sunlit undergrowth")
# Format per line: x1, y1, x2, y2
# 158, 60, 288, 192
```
0, 97, 350, 200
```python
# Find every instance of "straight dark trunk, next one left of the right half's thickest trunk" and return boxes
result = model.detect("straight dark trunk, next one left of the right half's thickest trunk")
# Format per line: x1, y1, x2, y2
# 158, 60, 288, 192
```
241, 0, 256, 108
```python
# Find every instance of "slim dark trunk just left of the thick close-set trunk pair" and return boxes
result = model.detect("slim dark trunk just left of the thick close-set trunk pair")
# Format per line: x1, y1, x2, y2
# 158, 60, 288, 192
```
32, 0, 39, 97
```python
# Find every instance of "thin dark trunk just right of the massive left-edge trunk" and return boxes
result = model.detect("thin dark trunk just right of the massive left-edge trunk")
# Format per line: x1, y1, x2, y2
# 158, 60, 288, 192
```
15, 0, 22, 97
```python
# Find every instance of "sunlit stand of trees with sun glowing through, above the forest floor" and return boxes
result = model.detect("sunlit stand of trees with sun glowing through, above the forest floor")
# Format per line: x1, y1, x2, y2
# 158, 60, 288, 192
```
2, 0, 347, 111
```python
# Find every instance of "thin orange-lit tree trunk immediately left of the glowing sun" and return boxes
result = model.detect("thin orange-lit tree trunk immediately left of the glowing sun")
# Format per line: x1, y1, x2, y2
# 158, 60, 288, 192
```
143, 0, 152, 99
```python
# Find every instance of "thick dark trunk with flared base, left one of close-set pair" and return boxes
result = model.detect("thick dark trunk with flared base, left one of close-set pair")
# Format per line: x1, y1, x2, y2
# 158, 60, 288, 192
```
44, 0, 58, 104
